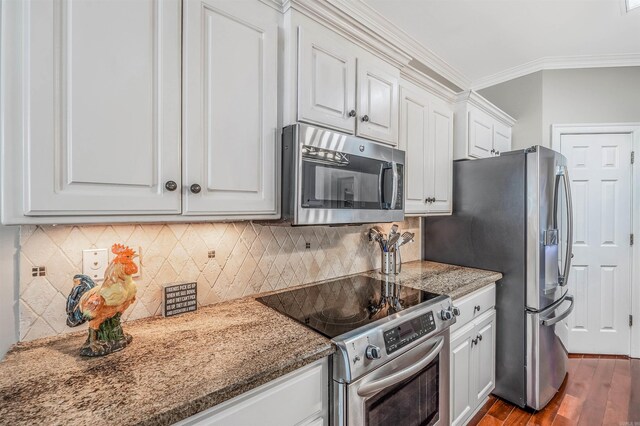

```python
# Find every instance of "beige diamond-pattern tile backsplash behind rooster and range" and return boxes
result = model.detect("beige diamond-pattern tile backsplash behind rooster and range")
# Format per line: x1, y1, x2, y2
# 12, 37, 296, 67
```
19, 218, 420, 340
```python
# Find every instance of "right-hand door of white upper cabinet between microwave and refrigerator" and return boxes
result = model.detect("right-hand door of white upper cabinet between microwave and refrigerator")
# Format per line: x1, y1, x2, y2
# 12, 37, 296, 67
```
425, 98, 453, 213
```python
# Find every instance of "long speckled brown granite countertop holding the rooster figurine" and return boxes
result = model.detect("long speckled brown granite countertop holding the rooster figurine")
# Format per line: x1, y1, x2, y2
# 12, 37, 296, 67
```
0, 299, 334, 425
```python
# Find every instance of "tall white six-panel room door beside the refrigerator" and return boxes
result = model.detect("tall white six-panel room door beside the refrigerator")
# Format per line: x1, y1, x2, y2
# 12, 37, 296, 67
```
560, 134, 632, 355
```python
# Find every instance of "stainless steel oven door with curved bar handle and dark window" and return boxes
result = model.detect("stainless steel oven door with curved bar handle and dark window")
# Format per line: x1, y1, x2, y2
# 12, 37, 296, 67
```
346, 331, 449, 426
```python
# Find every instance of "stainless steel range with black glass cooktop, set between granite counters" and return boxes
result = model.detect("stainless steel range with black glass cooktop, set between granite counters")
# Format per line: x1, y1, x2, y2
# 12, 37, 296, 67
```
258, 275, 458, 426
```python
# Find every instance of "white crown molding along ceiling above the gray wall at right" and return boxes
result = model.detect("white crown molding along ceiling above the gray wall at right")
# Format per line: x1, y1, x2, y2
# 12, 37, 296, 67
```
471, 53, 640, 90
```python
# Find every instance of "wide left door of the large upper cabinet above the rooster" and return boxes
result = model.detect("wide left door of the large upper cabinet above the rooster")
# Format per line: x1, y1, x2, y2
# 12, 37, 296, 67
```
23, 0, 181, 216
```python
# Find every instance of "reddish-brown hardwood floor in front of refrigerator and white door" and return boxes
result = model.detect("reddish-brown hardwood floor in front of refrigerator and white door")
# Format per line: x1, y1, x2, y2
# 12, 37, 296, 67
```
469, 355, 640, 426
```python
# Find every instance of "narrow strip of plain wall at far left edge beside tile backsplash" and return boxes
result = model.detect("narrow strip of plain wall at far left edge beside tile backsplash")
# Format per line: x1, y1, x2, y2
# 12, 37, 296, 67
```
0, 225, 20, 359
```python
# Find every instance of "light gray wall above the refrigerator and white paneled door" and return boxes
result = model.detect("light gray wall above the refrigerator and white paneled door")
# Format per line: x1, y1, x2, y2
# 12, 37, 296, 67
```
479, 67, 640, 149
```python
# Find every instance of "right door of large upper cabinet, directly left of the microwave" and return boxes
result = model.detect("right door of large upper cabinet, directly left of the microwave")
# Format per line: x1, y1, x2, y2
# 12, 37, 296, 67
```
183, 0, 280, 218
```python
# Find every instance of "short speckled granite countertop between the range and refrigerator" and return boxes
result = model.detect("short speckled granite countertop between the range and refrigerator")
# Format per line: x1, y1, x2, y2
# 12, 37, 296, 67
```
368, 260, 502, 300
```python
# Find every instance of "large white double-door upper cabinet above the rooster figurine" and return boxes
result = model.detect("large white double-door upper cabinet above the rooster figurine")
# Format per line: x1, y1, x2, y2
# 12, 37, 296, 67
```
1, 0, 282, 223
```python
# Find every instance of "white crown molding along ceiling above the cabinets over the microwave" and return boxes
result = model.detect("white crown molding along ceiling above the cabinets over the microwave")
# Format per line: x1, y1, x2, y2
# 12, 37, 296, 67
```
284, 0, 471, 88
